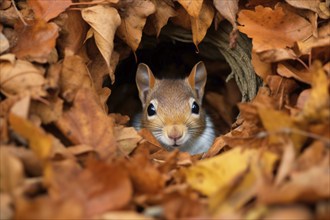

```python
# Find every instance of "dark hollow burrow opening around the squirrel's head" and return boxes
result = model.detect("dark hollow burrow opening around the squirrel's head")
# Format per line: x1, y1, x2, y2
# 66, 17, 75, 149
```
105, 36, 241, 134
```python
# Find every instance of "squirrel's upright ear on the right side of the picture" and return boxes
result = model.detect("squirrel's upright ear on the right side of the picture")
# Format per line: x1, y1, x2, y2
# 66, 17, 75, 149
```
187, 61, 207, 99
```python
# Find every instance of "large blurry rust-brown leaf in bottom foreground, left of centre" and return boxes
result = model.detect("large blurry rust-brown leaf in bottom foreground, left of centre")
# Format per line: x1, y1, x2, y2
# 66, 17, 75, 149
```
50, 159, 133, 218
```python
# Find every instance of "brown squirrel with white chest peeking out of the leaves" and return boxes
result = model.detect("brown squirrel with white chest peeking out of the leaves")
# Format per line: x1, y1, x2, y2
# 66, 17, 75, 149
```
133, 61, 215, 155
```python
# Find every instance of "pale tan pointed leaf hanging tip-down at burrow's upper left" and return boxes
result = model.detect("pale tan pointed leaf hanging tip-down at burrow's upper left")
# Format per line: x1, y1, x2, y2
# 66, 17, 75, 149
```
82, 5, 121, 80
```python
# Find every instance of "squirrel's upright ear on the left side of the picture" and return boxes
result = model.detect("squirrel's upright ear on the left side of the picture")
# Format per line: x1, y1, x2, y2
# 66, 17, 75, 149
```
135, 63, 155, 106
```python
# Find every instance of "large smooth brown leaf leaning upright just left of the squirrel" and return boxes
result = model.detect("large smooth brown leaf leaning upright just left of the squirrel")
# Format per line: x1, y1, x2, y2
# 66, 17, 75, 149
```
56, 88, 116, 158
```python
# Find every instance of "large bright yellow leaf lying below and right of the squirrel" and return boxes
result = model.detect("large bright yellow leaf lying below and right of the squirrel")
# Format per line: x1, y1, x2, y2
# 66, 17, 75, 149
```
186, 148, 277, 196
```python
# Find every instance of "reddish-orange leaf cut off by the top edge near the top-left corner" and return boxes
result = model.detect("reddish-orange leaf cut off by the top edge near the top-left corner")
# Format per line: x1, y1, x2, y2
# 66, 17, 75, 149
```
27, 0, 72, 21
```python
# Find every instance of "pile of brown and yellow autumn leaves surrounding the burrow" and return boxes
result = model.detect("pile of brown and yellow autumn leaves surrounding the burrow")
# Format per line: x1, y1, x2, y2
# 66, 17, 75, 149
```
0, 0, 330, 219
